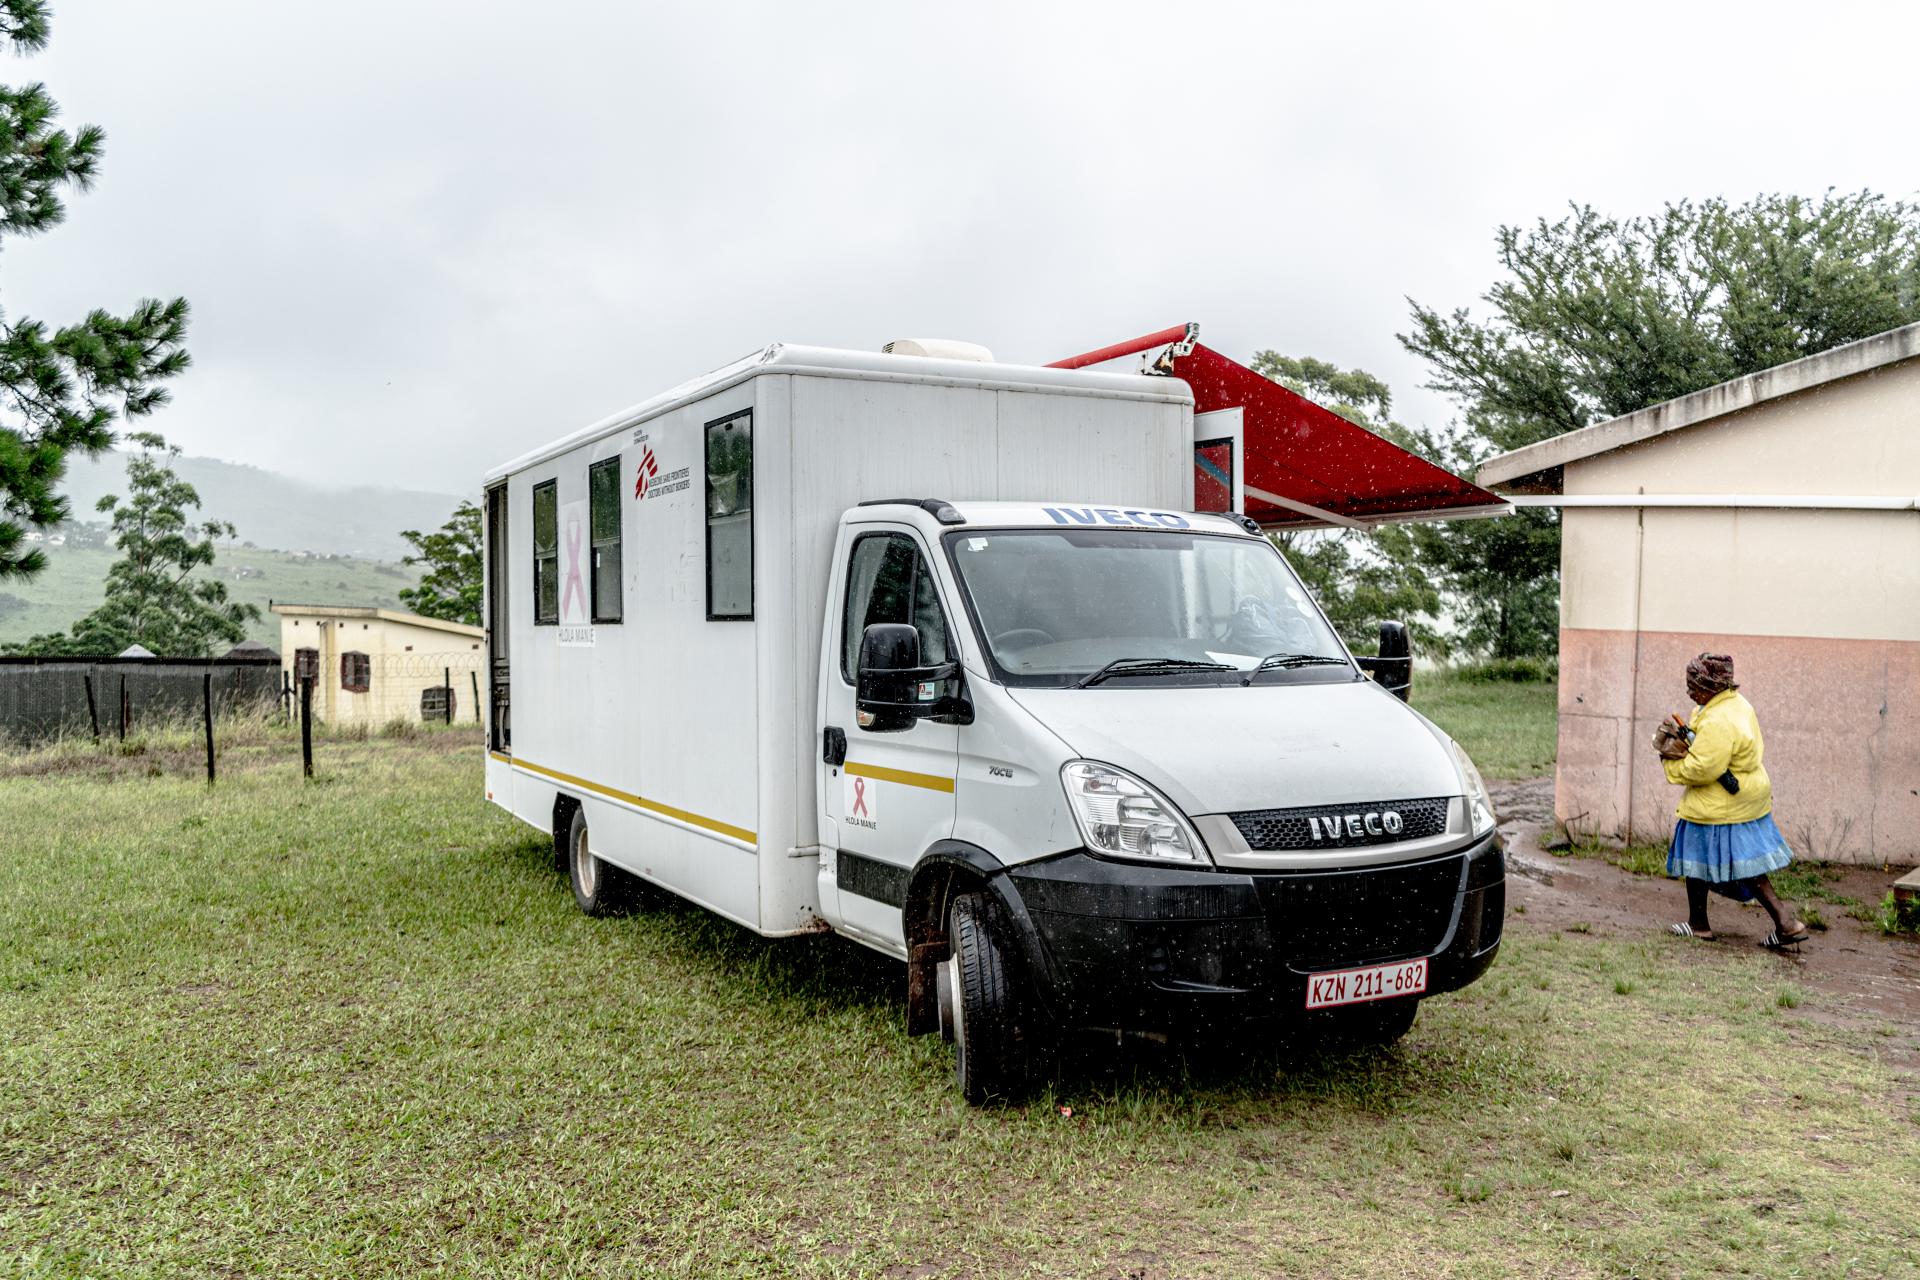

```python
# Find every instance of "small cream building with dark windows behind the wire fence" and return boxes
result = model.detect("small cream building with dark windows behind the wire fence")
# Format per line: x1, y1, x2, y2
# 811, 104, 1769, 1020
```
273, 604, 484, 727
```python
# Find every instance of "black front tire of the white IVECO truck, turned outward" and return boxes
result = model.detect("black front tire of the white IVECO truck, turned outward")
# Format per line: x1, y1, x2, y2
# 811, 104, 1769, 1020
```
939, 892, 1031, 1107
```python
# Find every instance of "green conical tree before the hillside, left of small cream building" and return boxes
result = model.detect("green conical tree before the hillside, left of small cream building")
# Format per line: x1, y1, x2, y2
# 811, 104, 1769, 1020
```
8, 432, 259, 658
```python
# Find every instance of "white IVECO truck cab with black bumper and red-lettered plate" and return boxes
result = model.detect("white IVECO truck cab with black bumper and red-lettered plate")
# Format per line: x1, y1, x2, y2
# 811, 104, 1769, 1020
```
816, 497, 1503, 1102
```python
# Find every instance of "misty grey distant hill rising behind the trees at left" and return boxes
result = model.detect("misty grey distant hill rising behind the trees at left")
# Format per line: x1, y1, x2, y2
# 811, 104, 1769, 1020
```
63, 453, 461, 564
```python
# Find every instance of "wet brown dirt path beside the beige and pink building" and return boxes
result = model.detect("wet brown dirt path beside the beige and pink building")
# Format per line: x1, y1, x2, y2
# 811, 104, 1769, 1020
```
1490, 777, 1920, 1090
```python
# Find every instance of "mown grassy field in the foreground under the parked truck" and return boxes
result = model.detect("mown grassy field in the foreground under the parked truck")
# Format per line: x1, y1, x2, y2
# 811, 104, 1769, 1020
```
0, 729, 1920, 1280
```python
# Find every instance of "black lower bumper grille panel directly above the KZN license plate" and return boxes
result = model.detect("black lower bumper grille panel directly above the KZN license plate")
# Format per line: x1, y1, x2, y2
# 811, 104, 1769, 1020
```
1254, 854, 1465, 969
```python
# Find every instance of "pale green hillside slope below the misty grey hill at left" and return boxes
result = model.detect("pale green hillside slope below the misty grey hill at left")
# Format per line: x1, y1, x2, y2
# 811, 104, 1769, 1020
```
0, 547, 419, 649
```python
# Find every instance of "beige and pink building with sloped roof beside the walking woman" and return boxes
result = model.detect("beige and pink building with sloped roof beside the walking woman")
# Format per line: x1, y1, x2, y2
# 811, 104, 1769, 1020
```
1476, 324, 1920, 864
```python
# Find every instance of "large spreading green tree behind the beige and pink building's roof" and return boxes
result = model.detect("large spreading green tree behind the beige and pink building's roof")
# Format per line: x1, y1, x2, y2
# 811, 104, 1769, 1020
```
1400, 192, 1920, 656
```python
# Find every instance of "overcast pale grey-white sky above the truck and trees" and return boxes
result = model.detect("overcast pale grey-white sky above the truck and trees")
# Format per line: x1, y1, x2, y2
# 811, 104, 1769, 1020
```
15, 0, 1920, 491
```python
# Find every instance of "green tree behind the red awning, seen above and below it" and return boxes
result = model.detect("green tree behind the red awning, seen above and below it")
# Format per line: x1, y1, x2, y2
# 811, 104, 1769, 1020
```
1252, 351, 1448, 654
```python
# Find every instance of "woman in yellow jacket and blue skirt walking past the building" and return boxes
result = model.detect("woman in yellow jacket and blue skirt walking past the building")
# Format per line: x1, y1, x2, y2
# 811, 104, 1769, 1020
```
1653, 652, 1807, 950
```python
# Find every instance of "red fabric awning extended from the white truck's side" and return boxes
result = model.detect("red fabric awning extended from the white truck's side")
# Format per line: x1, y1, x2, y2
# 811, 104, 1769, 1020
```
1058, 324, 1509, 528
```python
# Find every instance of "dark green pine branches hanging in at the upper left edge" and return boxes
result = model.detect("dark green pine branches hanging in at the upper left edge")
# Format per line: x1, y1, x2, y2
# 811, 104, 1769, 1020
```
0, 0, 186, 580
